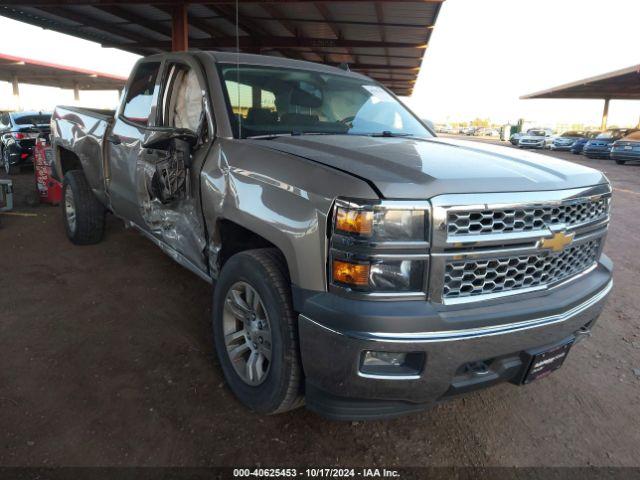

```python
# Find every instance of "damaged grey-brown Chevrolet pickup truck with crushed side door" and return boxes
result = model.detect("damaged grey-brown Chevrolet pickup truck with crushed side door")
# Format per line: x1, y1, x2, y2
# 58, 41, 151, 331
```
52, 52, 612, 419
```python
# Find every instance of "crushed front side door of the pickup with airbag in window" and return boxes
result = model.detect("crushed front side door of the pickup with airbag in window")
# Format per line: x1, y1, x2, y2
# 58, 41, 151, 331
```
136, 54, 213, 276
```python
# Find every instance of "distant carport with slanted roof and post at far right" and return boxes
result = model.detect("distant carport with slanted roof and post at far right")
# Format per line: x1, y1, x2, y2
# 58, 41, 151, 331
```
520, 65, 640, 130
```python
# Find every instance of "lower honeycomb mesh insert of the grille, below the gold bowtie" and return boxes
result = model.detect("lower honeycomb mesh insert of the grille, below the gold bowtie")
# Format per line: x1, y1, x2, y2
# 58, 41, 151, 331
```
442, 239, 600, 299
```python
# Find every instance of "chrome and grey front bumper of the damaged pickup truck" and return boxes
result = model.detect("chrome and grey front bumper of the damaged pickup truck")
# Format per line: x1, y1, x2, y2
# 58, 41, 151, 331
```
299, 256, 612, 420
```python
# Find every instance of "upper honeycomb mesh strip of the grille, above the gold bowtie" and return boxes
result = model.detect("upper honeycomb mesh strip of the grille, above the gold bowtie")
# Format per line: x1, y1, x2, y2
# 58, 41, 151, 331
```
447, 197, 609, 236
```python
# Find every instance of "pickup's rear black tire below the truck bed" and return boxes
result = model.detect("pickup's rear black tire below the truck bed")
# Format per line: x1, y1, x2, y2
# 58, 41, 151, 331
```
61, 170, 106, 245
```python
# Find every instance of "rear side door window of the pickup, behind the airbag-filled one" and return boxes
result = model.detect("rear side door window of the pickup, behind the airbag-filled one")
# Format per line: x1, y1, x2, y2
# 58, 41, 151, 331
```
122, 62, 160, 126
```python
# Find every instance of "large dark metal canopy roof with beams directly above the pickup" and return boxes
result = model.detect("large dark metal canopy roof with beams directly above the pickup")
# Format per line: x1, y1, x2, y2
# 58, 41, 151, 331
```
0, 0, 444, 95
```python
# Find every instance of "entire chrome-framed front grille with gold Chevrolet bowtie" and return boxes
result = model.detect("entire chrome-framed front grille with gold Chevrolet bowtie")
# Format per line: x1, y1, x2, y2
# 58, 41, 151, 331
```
429, 185, 611, 304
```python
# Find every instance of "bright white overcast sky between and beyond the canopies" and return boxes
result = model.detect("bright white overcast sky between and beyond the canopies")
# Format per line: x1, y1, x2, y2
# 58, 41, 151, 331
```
0, 0, 640, 127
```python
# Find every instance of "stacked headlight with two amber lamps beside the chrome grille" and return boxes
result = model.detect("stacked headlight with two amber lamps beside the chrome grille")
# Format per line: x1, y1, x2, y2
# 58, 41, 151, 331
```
328, 199, 429, 294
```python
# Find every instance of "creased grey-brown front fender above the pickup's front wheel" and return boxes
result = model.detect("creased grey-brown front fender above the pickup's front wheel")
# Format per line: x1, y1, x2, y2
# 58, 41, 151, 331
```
202, 139, 377, 291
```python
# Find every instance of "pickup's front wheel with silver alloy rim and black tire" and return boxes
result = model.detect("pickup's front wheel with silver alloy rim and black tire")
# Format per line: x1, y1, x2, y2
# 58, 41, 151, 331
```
213, 249, 302, 414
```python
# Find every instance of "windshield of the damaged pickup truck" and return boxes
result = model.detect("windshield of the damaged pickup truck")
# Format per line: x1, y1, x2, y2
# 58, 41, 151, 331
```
220, 65, 433, 138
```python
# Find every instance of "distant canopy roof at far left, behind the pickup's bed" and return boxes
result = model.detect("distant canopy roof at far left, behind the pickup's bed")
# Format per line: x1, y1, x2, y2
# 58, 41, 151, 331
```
0, 53, 127, 90
